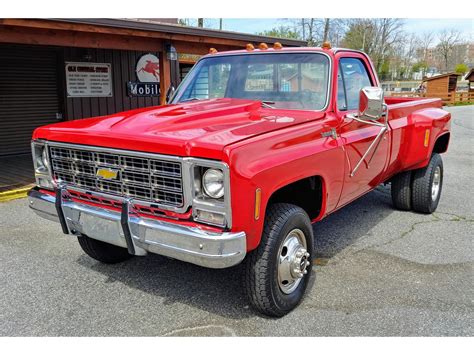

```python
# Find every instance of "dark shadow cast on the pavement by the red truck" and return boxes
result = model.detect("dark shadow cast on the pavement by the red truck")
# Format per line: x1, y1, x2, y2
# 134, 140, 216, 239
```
77, 187, 392, 319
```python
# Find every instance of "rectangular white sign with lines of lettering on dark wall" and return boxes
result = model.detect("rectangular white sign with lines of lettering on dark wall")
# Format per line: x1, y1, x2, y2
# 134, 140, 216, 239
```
66, 63, 112, 97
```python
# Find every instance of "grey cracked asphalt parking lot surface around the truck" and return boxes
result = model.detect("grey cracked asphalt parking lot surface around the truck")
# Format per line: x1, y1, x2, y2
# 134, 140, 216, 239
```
0, 106, 474, 336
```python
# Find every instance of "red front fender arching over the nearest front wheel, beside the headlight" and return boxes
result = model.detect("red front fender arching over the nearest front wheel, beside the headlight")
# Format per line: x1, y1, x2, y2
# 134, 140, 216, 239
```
225, 121, 345, 251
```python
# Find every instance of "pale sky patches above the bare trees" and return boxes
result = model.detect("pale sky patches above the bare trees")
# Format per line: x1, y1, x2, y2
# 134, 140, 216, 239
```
193, 18, 474, 40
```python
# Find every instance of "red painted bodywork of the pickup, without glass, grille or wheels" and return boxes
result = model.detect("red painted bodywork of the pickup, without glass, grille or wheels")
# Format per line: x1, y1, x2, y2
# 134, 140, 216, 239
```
33, 48, 451, 250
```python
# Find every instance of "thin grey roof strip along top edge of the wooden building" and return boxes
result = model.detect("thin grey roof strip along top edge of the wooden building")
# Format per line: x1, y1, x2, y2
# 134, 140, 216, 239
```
50, 18, 307, 47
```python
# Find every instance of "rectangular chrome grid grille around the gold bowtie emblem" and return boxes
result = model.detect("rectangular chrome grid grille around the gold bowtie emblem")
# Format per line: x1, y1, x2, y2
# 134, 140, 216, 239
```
49, 145, 184, 207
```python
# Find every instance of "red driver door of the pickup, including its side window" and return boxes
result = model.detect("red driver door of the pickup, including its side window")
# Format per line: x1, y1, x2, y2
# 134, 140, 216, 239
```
337, 53, 389, 207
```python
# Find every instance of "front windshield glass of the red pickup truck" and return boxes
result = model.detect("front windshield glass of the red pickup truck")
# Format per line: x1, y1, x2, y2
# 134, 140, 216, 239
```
172, 53, 329, 110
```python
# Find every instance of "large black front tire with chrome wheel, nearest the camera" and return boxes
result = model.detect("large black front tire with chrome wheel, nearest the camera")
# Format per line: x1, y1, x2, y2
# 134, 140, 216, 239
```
244, 203, 314, 317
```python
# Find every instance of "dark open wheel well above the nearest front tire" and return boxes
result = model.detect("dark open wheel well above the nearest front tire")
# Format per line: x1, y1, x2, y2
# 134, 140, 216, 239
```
267, 176, 323, 219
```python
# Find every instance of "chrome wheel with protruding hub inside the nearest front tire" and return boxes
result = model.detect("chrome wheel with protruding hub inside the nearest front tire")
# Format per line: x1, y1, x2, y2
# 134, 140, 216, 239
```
278, 229, 310, 294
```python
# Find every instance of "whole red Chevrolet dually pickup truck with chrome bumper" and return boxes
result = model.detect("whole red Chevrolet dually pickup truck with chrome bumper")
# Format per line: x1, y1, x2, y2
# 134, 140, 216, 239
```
29, 46, 451, 316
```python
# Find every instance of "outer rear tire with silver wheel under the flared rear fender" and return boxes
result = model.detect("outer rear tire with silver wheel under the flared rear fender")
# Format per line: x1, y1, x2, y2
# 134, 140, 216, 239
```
412, 153, 443, 213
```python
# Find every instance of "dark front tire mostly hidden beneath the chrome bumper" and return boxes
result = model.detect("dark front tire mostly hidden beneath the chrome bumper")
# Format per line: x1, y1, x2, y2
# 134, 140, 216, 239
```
77, 235, 133, 264
